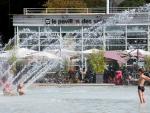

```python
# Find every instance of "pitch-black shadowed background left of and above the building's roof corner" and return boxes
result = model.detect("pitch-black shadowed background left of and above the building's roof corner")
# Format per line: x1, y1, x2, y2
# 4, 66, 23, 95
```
0, 0, 45, 45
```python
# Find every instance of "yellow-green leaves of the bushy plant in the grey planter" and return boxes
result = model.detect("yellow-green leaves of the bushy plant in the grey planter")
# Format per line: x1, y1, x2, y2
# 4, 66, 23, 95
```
88, 51, 106, 73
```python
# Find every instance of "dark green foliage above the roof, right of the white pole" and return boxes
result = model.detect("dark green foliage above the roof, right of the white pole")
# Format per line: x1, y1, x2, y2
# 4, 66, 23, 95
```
119, 0, 145, 7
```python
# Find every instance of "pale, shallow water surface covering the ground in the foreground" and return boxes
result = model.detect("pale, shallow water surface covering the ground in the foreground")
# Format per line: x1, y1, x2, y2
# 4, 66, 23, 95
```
0, 84, 150, 113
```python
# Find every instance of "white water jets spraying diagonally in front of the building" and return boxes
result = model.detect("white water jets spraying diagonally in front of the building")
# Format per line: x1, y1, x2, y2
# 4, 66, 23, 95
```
0, 4, 150, 92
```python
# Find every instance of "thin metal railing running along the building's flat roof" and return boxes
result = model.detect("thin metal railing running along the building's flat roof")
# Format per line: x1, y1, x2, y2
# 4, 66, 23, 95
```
24, 7, 146, 15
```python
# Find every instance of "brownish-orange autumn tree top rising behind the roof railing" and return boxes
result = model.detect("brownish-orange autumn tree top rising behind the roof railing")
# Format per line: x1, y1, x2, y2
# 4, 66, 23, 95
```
44, 0, 87, 8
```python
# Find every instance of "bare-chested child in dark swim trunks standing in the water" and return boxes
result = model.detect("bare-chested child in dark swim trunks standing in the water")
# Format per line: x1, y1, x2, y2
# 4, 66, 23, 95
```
138, 68, 150, 104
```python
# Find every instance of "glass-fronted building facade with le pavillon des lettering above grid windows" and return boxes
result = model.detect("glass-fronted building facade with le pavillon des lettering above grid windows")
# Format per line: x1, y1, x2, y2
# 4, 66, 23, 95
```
13, 8, 150, 68
